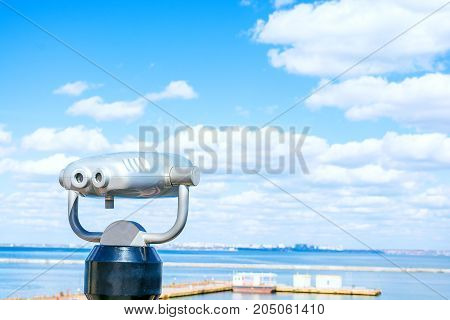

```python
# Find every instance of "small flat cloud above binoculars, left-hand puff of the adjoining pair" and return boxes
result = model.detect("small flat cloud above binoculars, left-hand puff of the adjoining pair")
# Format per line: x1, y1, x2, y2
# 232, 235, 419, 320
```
67, 96, 147, 121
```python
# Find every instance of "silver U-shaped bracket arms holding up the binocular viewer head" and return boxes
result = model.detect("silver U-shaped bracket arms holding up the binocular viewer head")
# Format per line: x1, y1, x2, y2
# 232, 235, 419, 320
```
68, 185, 189, 244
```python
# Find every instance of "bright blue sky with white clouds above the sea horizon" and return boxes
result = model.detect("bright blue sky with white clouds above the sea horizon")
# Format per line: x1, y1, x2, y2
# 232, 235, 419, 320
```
0, 0, 450, 249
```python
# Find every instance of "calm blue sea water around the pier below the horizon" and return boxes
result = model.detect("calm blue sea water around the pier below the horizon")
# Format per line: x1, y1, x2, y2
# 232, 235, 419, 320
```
0, 247, 450, 299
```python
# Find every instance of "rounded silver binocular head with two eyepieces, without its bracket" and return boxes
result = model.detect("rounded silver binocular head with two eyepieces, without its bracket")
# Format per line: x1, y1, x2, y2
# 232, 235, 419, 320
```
59, 152, 200, 198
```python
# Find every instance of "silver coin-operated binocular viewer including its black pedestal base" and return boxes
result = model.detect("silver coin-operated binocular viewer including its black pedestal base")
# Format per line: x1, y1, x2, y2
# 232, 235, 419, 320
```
59, 152, 200, 299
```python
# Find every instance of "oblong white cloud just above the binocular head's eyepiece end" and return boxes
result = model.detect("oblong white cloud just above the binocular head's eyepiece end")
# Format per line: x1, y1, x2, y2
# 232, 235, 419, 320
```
22, 126, 109, 152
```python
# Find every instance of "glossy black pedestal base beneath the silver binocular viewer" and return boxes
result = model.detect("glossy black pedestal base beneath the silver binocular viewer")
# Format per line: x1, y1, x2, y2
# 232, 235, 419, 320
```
84, 245, 162, 300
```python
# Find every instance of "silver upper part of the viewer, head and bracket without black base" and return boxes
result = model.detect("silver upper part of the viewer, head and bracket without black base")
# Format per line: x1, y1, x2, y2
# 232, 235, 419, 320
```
59, 153, 200, 246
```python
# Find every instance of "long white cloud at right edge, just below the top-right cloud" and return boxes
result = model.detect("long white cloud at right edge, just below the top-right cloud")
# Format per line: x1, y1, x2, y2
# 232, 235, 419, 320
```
306, 73, 450, 130
